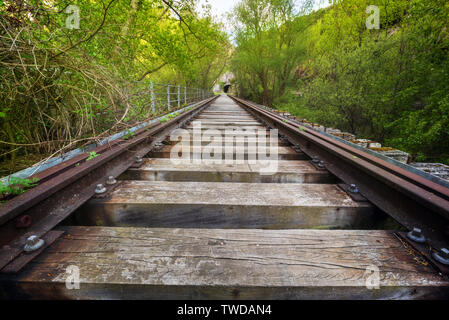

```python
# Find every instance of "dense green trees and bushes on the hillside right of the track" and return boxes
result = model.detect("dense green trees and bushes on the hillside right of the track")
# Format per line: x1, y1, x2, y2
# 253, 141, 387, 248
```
231, 0, 449, 164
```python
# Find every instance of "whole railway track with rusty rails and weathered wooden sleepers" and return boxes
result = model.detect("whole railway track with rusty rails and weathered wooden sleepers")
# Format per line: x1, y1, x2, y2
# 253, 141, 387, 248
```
0, 96, 449, 299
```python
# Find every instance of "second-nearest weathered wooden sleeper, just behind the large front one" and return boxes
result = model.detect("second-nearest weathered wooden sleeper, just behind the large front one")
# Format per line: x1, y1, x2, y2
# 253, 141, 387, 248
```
76, 181, 374, 229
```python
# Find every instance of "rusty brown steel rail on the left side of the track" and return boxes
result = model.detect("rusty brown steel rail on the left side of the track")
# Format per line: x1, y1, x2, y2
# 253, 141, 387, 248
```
0, 96, 217, 272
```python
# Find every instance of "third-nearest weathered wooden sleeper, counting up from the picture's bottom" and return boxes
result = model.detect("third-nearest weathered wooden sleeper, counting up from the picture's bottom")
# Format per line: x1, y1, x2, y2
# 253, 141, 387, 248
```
121, 158, 336, 183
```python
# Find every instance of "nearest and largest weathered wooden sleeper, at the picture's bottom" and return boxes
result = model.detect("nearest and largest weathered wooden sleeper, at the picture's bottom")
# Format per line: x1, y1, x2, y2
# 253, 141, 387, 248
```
0, 227, 449, 299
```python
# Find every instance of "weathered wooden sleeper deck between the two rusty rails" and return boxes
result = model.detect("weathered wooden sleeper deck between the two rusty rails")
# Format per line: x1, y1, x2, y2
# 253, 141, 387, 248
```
1, 97, 449, 299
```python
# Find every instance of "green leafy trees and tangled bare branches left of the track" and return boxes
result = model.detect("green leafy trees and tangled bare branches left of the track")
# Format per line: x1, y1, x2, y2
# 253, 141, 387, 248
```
0, 0, 230, 176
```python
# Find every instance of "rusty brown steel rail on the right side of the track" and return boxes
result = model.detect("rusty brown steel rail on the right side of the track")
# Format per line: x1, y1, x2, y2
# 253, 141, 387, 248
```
231, 96, 449, 272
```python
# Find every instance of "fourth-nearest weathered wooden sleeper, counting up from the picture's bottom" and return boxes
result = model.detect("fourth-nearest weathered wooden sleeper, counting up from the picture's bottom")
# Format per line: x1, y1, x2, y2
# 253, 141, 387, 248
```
148, 145, 307, 160
